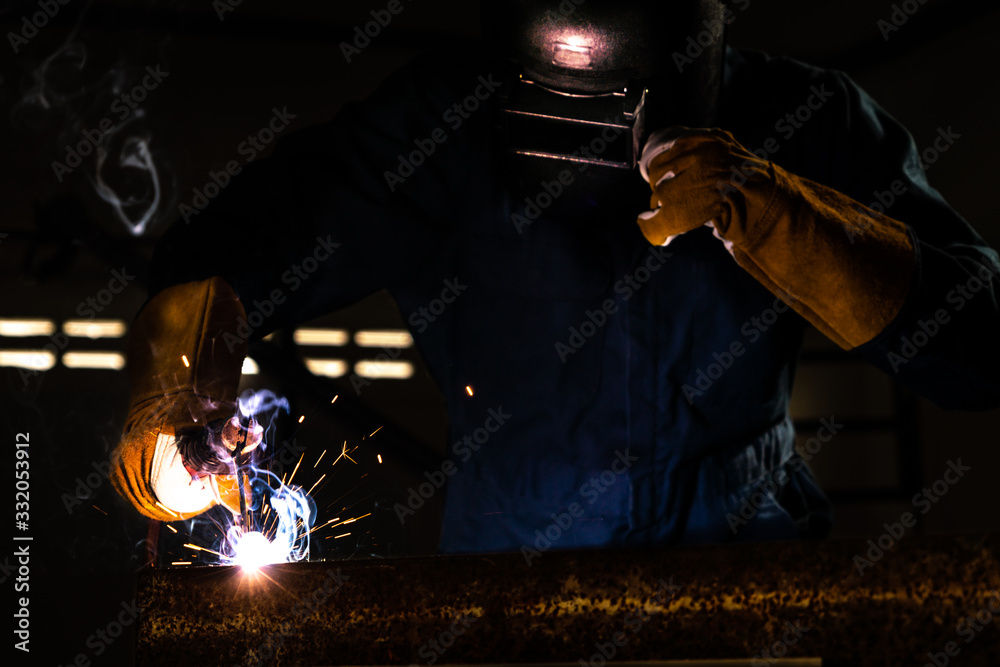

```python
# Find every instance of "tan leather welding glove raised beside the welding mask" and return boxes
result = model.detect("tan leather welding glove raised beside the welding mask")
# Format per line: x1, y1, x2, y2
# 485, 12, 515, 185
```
638, 128, 916, 349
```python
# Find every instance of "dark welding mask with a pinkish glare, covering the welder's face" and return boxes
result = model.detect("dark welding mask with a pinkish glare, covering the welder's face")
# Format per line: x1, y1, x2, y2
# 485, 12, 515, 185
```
482, 0, 732, 218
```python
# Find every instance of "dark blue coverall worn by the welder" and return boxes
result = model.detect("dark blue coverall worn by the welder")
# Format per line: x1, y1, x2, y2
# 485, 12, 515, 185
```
153, 49, 1000, 552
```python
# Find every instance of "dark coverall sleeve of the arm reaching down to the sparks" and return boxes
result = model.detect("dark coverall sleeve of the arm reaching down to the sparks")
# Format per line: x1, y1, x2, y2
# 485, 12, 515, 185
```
150, 56, 484, 334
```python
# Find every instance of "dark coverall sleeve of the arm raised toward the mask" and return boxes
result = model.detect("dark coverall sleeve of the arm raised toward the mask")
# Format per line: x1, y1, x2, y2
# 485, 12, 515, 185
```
816, 73, 1000, 410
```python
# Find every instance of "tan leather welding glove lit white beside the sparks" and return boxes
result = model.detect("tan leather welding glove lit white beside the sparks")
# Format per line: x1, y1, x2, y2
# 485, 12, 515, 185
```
111, 278, 260, 521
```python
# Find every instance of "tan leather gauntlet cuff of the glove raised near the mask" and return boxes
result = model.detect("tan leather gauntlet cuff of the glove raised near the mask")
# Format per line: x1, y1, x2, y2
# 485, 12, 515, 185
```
716, 163, 915, 349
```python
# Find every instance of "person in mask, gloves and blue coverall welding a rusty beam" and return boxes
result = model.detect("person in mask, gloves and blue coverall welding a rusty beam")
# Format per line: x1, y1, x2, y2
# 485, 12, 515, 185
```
114, 0, 1000, 552
